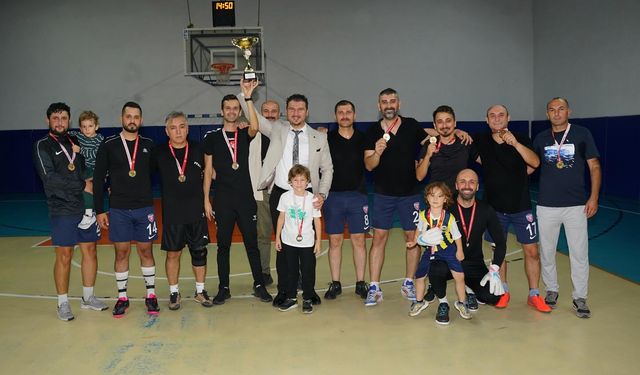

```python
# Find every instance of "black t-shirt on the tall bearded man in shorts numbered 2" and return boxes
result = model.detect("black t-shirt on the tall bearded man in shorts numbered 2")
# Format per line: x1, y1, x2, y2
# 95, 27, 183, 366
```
363, 117, 427, 197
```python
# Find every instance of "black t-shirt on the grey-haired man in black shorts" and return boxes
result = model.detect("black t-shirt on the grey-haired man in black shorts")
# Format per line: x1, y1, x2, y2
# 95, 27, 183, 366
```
154, 142, 204, 224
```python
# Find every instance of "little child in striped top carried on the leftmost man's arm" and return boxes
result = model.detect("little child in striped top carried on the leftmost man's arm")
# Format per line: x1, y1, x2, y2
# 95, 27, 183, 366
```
69, 111, 104, 229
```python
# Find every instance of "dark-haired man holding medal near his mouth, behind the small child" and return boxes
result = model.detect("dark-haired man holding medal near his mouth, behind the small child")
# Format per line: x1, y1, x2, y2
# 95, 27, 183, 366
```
416, 105, 471, 191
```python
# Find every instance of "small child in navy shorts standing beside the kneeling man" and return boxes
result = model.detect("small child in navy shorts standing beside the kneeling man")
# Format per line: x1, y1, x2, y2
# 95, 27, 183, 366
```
407, 182, 471, 322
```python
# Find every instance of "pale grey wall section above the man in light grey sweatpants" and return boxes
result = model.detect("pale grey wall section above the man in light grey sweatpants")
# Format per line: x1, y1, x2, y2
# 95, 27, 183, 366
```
533, 0, 640, 119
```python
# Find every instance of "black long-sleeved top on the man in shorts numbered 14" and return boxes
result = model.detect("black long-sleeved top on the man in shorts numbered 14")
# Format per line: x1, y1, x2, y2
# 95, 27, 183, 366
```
93, 134, 154, 213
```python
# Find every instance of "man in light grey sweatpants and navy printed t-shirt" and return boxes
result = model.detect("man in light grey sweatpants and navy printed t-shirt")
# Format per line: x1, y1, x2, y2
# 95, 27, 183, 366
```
533, 98, 602, 318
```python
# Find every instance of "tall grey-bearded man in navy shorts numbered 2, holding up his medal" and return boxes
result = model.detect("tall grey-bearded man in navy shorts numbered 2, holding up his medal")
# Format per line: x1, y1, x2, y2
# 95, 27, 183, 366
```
364, 88, 427, 306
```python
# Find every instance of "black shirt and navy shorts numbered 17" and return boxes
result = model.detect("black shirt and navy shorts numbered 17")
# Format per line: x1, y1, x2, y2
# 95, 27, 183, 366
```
472, 133, 538, 244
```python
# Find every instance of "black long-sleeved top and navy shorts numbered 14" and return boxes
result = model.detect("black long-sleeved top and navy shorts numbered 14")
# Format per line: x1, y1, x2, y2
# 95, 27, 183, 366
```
93, 134, 158, 242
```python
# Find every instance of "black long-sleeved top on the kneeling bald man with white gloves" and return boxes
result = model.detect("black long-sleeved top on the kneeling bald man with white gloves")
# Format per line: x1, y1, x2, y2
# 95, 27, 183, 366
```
449, 199, 507, 267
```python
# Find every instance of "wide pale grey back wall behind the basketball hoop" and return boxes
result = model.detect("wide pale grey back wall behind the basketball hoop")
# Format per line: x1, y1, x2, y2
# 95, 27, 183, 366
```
0, 0, 534, 130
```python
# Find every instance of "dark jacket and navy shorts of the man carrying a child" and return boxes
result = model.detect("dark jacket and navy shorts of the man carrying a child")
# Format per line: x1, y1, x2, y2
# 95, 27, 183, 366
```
33, 134, 100, 247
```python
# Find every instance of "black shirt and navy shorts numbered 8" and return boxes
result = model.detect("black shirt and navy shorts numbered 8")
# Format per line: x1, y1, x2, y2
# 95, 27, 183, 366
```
322, 129, 369, 234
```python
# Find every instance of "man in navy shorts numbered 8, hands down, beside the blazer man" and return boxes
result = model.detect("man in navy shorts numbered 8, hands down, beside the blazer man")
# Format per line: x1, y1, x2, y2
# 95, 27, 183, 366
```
324, 100, 369, 299
